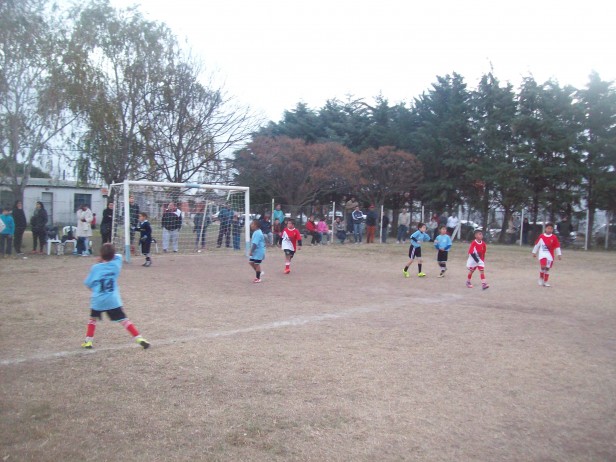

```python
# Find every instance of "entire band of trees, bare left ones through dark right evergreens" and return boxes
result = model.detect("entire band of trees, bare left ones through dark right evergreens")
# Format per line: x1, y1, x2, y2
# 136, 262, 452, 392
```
0, 0, 616, 245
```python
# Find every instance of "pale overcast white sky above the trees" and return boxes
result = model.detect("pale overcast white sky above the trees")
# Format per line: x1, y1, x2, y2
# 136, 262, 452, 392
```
111, 0, 616, 121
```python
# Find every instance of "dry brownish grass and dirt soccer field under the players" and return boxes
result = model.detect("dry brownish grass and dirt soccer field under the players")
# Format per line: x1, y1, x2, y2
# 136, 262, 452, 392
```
0, 243, 616, 462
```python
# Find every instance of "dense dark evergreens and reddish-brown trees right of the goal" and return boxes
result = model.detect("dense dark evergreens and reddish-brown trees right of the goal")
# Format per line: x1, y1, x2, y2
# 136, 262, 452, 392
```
234, 72, 616, 242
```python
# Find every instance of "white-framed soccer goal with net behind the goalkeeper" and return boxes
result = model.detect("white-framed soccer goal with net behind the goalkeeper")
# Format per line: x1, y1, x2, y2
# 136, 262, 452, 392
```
110, 181, 250, 262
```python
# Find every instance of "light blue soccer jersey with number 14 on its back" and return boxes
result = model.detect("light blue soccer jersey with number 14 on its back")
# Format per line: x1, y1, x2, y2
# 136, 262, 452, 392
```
83, 255, 122, 311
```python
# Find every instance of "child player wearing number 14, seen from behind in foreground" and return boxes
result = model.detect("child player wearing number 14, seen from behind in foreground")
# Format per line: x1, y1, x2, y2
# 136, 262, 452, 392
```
81, 243, 150, 349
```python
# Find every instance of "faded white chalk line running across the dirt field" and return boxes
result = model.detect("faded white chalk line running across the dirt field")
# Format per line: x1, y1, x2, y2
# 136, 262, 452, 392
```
0, 294, 461, 366
